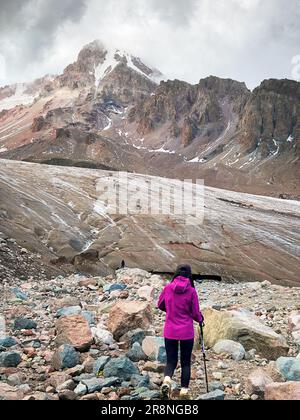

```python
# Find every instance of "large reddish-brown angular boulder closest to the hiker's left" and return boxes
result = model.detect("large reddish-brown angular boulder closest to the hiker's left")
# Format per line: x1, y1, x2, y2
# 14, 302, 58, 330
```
108, 301, 152, 341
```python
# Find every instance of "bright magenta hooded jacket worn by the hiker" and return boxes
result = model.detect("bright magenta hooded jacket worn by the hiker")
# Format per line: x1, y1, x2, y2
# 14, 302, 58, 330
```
157, 277, 203, 340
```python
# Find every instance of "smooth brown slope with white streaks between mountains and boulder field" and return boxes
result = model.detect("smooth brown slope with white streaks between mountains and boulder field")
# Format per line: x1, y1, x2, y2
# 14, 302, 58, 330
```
0, 160, 300, 285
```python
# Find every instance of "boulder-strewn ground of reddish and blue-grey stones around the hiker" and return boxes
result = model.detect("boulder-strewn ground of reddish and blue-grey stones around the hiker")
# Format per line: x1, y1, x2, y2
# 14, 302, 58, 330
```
0, 269, 300, 400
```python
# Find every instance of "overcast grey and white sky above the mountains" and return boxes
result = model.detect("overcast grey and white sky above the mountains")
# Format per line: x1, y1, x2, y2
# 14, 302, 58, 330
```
0, 0, 300, 88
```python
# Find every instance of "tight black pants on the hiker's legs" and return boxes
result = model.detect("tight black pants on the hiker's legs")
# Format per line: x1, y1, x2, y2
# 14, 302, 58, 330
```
165, 338, 194, 388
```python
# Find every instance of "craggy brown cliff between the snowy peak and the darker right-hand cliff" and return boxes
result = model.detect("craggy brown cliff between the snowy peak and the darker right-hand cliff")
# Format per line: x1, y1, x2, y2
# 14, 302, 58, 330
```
132, 77, 249, 148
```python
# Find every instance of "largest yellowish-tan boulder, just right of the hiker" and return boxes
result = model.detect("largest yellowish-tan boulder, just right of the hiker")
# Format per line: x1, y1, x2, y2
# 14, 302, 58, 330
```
203, 308, 289, 360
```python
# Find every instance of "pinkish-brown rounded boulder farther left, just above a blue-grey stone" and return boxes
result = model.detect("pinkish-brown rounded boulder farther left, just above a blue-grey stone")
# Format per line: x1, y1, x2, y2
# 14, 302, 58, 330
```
55, 315, 94, 352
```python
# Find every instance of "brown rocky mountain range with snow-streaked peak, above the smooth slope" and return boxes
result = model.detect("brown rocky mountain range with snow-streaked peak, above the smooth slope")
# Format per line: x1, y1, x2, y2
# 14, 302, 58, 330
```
0, 41, 300, 198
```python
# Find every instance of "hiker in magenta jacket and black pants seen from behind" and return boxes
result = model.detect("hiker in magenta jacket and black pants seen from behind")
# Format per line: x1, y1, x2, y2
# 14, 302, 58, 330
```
157, 265, 204, 399
